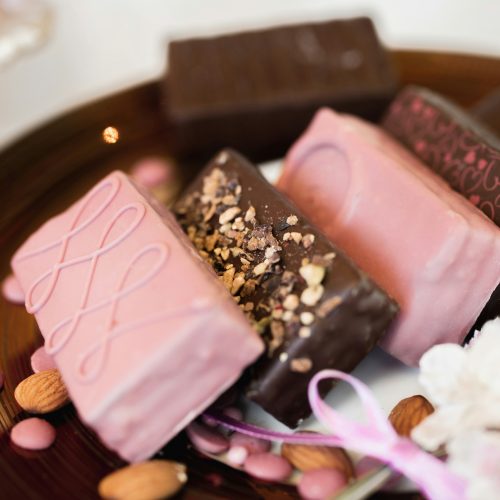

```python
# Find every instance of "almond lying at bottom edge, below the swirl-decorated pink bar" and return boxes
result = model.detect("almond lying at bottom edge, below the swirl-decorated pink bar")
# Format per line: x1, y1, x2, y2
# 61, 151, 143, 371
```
99, 460, 187, 500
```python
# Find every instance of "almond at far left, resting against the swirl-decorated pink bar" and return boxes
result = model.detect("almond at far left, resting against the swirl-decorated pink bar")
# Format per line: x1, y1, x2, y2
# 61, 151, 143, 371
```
14, 369, 69, 413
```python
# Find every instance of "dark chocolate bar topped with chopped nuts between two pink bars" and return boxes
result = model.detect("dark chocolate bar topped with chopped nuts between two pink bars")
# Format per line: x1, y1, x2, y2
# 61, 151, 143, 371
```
174, 150, 398, 427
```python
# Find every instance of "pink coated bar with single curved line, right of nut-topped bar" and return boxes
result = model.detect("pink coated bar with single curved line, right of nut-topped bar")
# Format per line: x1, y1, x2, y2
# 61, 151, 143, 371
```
278, 109, 500, 364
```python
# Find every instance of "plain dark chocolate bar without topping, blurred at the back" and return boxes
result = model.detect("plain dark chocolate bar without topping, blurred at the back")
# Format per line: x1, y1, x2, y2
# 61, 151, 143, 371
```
164, 18, 397, 159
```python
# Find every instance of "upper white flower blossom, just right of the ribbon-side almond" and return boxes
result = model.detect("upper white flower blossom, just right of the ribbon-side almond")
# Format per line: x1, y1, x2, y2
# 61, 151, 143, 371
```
412, 318, 500, 450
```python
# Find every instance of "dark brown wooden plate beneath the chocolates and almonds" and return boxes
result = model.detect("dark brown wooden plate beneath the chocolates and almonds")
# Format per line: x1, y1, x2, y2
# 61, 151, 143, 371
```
0, 51, 500, 499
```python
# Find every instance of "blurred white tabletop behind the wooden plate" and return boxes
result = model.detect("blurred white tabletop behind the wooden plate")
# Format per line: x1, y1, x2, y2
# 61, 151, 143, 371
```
0, 0, 500, 148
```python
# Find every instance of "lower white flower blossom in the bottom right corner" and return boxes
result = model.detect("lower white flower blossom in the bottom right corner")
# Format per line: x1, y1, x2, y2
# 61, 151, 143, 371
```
448, 430, 500, 500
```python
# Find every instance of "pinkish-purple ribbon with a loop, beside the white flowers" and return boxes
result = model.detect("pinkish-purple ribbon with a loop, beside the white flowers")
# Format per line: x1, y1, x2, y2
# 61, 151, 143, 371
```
207, 370, 465, 500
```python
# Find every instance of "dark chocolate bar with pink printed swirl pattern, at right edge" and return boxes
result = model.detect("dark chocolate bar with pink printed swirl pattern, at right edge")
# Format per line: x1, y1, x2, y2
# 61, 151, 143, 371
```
382, 86, 500, 225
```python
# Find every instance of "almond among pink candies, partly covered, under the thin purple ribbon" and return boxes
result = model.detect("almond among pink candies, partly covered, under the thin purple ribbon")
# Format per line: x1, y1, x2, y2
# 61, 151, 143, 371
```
281, 443, 355, 481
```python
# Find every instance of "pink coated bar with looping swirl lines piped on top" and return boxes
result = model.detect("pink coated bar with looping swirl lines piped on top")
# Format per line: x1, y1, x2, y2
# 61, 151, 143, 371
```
12, 172, 263, 461
